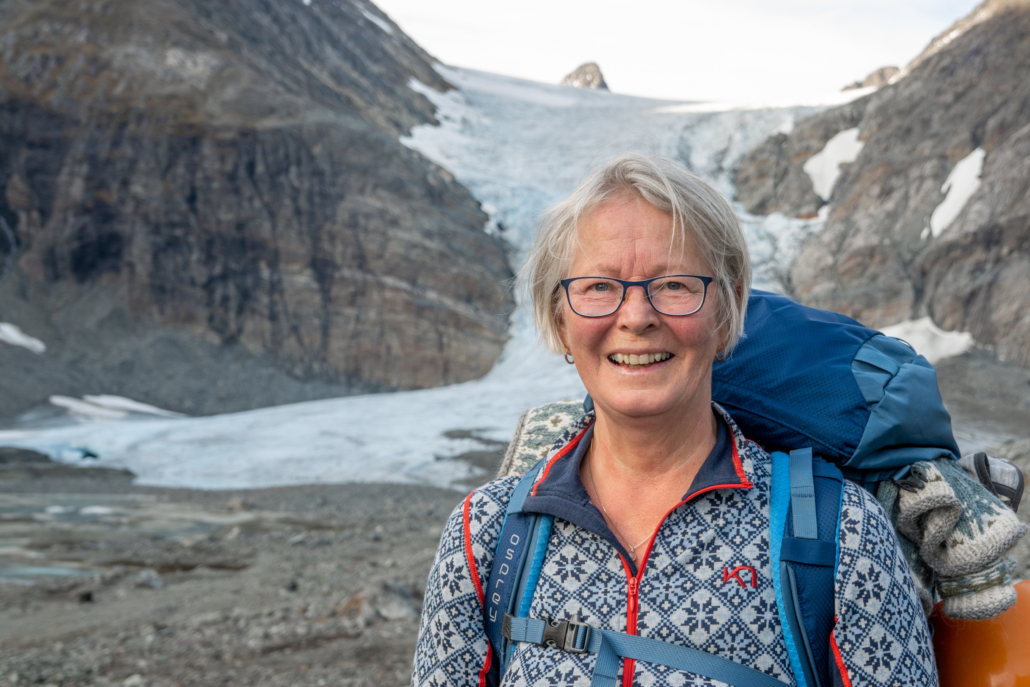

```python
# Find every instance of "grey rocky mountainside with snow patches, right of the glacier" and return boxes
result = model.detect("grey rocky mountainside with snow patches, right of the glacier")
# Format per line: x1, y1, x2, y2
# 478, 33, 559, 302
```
735, 0, 1030, 365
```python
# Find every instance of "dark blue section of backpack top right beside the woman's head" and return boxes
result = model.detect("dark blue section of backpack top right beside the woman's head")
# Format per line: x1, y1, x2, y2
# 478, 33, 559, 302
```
712, 290, 878, 462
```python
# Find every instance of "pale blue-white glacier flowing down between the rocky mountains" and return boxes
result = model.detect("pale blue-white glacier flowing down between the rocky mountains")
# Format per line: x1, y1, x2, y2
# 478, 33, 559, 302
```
0, 66, 836, 489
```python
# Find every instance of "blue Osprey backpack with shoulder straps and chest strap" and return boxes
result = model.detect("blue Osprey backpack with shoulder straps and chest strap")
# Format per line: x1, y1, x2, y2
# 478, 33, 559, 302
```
484, 290, 959, 687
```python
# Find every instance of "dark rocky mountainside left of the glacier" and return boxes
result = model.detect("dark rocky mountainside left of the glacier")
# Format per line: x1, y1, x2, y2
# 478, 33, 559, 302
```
0, 0, 513, 416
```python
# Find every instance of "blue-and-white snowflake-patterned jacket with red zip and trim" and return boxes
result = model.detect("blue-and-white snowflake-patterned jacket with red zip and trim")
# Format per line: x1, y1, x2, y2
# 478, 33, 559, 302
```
412, 406, 937, 687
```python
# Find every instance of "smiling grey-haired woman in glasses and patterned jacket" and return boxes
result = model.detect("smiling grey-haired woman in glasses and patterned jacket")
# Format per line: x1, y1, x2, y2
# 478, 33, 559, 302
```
413, 154, 936, 687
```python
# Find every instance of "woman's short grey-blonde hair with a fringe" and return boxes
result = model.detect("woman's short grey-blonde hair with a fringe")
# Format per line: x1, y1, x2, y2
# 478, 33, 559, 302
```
519, 153, 751, 354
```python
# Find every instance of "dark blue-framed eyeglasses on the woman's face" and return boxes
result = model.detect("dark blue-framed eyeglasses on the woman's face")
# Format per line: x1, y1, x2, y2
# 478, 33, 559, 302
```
561, 274, 715, 317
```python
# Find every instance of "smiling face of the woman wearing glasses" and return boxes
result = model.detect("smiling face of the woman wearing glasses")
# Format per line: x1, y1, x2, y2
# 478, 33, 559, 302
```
561, 190, 722, 417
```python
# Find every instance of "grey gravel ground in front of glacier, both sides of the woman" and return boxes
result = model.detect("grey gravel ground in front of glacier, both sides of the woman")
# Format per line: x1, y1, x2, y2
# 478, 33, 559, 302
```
0, 352, 1030, 687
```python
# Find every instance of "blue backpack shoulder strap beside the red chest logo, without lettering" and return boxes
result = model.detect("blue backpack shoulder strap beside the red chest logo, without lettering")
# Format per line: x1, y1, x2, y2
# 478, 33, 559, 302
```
769, 448, 844, 687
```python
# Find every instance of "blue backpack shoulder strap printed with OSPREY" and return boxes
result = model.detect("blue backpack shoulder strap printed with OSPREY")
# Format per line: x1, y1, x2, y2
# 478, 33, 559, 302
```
483, 459, 554, 676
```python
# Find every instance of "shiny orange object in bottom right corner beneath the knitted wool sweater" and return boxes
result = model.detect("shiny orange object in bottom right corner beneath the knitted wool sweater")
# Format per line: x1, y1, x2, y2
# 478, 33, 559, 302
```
930, 580, 1030, 687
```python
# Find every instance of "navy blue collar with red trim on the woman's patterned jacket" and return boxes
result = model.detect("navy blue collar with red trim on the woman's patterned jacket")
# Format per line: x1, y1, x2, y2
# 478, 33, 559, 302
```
522, 418, 748, 576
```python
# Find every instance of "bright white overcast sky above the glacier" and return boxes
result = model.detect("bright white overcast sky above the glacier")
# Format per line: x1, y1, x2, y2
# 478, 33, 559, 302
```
370, 0, 976, 103
